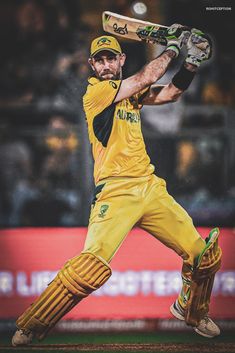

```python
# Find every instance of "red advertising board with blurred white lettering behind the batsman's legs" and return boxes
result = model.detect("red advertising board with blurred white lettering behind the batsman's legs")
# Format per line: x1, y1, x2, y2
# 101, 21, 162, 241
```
0, 228, 235, 320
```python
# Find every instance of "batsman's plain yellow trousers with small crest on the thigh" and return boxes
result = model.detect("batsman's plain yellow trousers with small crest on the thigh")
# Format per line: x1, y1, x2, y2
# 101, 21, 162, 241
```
84, 175, 205, 307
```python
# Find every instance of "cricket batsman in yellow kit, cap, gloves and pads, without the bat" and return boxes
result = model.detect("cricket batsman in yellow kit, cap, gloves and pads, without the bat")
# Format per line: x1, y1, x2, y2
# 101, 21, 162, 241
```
12, 24, 221, 346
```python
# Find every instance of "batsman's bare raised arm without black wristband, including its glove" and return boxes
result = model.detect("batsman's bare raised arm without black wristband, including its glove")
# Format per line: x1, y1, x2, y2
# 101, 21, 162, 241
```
114, 24, 189, 102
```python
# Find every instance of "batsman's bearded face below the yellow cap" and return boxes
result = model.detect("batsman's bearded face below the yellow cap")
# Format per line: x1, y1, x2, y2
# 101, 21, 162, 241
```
89, 50, 126, 81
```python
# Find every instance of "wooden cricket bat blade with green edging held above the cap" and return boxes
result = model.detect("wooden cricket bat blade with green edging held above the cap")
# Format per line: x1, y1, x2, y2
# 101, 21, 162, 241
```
102, 11, 168, 45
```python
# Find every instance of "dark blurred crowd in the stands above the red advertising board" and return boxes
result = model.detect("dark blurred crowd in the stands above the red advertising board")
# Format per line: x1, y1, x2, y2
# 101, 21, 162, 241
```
0, 0, 235, 226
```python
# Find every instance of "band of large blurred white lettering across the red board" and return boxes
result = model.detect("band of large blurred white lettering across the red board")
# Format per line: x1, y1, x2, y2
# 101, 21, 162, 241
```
0, 270, 235, 297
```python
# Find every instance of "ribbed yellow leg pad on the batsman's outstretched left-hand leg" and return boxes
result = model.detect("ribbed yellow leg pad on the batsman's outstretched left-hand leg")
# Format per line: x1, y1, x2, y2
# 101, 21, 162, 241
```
16, 252, 111, 340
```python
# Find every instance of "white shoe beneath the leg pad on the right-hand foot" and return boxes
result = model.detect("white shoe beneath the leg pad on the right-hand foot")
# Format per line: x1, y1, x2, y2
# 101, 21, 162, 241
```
170, 300, 220, 338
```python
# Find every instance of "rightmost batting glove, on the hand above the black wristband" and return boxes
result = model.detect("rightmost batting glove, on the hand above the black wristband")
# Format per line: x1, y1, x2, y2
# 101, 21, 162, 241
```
185, 28, 212, 67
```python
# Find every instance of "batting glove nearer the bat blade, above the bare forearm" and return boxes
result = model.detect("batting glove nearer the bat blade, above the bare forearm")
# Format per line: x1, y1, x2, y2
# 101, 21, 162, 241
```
166, 23, 191, 57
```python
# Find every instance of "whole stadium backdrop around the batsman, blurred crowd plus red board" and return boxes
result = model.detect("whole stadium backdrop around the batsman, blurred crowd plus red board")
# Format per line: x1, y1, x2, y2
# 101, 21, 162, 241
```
0, 0, 235, 350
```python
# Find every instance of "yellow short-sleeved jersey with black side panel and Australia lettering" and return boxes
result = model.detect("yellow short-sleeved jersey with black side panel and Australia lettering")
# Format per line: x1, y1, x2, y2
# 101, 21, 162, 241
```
83, 77, 154, 184
